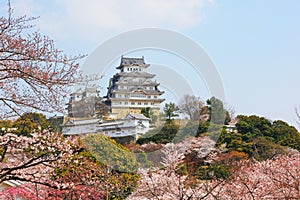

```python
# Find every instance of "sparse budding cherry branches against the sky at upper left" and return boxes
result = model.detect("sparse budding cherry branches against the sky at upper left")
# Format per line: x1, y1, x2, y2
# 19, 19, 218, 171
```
0, 0, 83, 117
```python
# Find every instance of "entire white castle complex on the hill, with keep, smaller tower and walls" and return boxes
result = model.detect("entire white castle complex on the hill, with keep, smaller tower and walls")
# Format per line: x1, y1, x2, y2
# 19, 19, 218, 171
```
62, 57, 164, 140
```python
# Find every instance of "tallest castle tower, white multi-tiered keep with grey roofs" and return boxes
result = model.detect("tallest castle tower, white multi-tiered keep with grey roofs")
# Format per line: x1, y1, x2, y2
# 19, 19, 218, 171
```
106, 56, 164, 118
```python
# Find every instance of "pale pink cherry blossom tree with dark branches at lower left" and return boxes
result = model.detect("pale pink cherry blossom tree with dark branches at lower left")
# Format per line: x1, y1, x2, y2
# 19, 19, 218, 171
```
0, 131, 79, 187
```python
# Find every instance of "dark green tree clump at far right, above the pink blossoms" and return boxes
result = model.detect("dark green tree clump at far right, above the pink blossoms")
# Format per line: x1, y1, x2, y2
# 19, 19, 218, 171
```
218, 115, 300, 160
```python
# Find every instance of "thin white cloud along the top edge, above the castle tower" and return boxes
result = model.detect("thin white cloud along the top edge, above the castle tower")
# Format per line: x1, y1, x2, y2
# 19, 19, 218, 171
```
64, 0, 211, 30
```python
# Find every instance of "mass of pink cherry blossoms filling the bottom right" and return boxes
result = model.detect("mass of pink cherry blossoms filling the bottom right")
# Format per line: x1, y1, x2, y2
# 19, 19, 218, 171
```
128, 135, 300, 200
